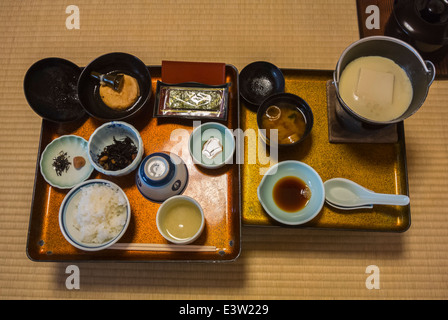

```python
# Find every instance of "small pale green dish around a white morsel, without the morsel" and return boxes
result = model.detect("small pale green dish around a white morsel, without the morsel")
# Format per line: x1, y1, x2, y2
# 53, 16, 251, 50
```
188, 122, 235, 169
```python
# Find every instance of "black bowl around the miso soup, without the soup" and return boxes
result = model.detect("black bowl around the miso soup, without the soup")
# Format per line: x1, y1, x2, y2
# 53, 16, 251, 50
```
257, 93, 314, 147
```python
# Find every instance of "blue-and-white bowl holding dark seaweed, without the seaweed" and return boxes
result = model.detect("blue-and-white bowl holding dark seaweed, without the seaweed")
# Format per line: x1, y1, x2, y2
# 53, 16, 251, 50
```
88, 121, 143, 177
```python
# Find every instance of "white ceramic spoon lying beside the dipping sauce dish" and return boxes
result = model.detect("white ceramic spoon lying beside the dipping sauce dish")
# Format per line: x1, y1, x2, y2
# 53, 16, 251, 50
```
324, 178, 409, 210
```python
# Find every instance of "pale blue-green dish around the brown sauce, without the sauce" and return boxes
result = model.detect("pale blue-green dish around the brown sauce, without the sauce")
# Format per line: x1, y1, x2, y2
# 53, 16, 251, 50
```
257, 160, 325, 225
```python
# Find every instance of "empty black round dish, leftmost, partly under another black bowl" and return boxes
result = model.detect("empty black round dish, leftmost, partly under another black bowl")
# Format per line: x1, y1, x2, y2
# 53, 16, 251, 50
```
23, 58, 86, 123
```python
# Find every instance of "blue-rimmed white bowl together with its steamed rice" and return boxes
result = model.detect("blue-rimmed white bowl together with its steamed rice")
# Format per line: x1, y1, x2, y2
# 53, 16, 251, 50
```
59, 179, 130, 251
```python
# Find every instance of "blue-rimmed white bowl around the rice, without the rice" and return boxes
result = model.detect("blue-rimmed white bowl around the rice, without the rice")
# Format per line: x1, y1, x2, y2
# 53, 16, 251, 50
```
59, 179, 131, 251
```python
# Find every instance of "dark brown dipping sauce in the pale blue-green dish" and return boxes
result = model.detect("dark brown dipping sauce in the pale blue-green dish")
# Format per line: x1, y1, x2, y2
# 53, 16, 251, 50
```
273, 176, 311, 212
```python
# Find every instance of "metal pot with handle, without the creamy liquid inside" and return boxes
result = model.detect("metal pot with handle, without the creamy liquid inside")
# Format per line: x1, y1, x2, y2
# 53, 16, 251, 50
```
333, 36, 436, 125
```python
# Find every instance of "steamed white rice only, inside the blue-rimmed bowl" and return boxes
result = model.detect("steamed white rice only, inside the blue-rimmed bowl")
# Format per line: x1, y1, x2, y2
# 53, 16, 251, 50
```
74, 184, 127, 244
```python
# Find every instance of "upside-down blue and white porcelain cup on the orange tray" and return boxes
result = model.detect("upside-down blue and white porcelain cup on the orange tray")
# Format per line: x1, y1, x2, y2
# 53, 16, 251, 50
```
135, 152, 188, 203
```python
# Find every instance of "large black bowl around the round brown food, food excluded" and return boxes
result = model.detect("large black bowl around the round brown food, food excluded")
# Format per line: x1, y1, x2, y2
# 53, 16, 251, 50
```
78, 52, 151, 121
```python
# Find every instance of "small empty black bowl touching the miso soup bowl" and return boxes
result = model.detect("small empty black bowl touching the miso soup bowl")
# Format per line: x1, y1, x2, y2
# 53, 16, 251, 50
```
239, 61, 285, 106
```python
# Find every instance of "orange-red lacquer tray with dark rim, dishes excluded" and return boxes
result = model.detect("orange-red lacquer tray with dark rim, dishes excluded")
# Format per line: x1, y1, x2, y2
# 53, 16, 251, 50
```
27, 65, 241, 262
